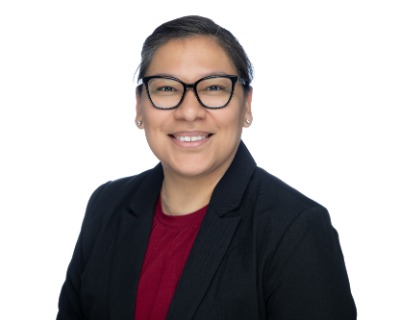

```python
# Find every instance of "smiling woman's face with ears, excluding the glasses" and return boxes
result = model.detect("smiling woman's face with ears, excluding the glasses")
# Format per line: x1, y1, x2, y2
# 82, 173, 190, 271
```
136, 36, 252, 177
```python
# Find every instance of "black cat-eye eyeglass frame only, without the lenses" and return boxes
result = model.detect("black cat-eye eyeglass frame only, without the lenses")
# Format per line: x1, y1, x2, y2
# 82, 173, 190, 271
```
138, 74, 249, 110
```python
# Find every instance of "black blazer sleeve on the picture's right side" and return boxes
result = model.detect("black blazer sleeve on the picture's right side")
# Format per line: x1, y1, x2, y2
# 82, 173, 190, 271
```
264, 206, 357, 320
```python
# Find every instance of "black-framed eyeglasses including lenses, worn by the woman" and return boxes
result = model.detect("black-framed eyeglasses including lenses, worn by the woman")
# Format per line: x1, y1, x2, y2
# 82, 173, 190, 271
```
138, 75, 248, 110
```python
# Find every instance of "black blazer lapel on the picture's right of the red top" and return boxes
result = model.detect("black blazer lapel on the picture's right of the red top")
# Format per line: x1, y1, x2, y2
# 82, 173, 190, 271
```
167, 143, 256, 320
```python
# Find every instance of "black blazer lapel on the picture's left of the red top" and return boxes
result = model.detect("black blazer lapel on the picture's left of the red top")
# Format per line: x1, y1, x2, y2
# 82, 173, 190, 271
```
110, 165, 163, 320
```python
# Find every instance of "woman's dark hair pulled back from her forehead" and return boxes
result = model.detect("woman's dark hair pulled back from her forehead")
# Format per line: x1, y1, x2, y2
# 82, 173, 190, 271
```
138, 15, 253, 88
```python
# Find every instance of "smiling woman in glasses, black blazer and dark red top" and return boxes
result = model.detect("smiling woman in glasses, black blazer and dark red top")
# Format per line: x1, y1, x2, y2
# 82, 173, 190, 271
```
57, 16, 356, 320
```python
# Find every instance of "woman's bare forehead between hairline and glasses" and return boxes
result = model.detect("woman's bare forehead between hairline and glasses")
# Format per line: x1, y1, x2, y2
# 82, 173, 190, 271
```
146, 36, 237, 81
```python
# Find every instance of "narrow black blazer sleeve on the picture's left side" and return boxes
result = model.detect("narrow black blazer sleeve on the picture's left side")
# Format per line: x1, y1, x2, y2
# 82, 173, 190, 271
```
57, 184, 107, 320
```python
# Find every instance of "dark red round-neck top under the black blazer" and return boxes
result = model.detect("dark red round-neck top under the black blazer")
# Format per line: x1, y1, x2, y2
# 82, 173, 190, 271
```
135, 199, 208, 320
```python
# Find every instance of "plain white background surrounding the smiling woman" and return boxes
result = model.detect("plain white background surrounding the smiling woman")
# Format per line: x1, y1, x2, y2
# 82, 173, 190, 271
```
0, 0, 400, 320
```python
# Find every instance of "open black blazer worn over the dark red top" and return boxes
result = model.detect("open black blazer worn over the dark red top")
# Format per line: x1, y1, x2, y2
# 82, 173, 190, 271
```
57, 142, 356, 320
